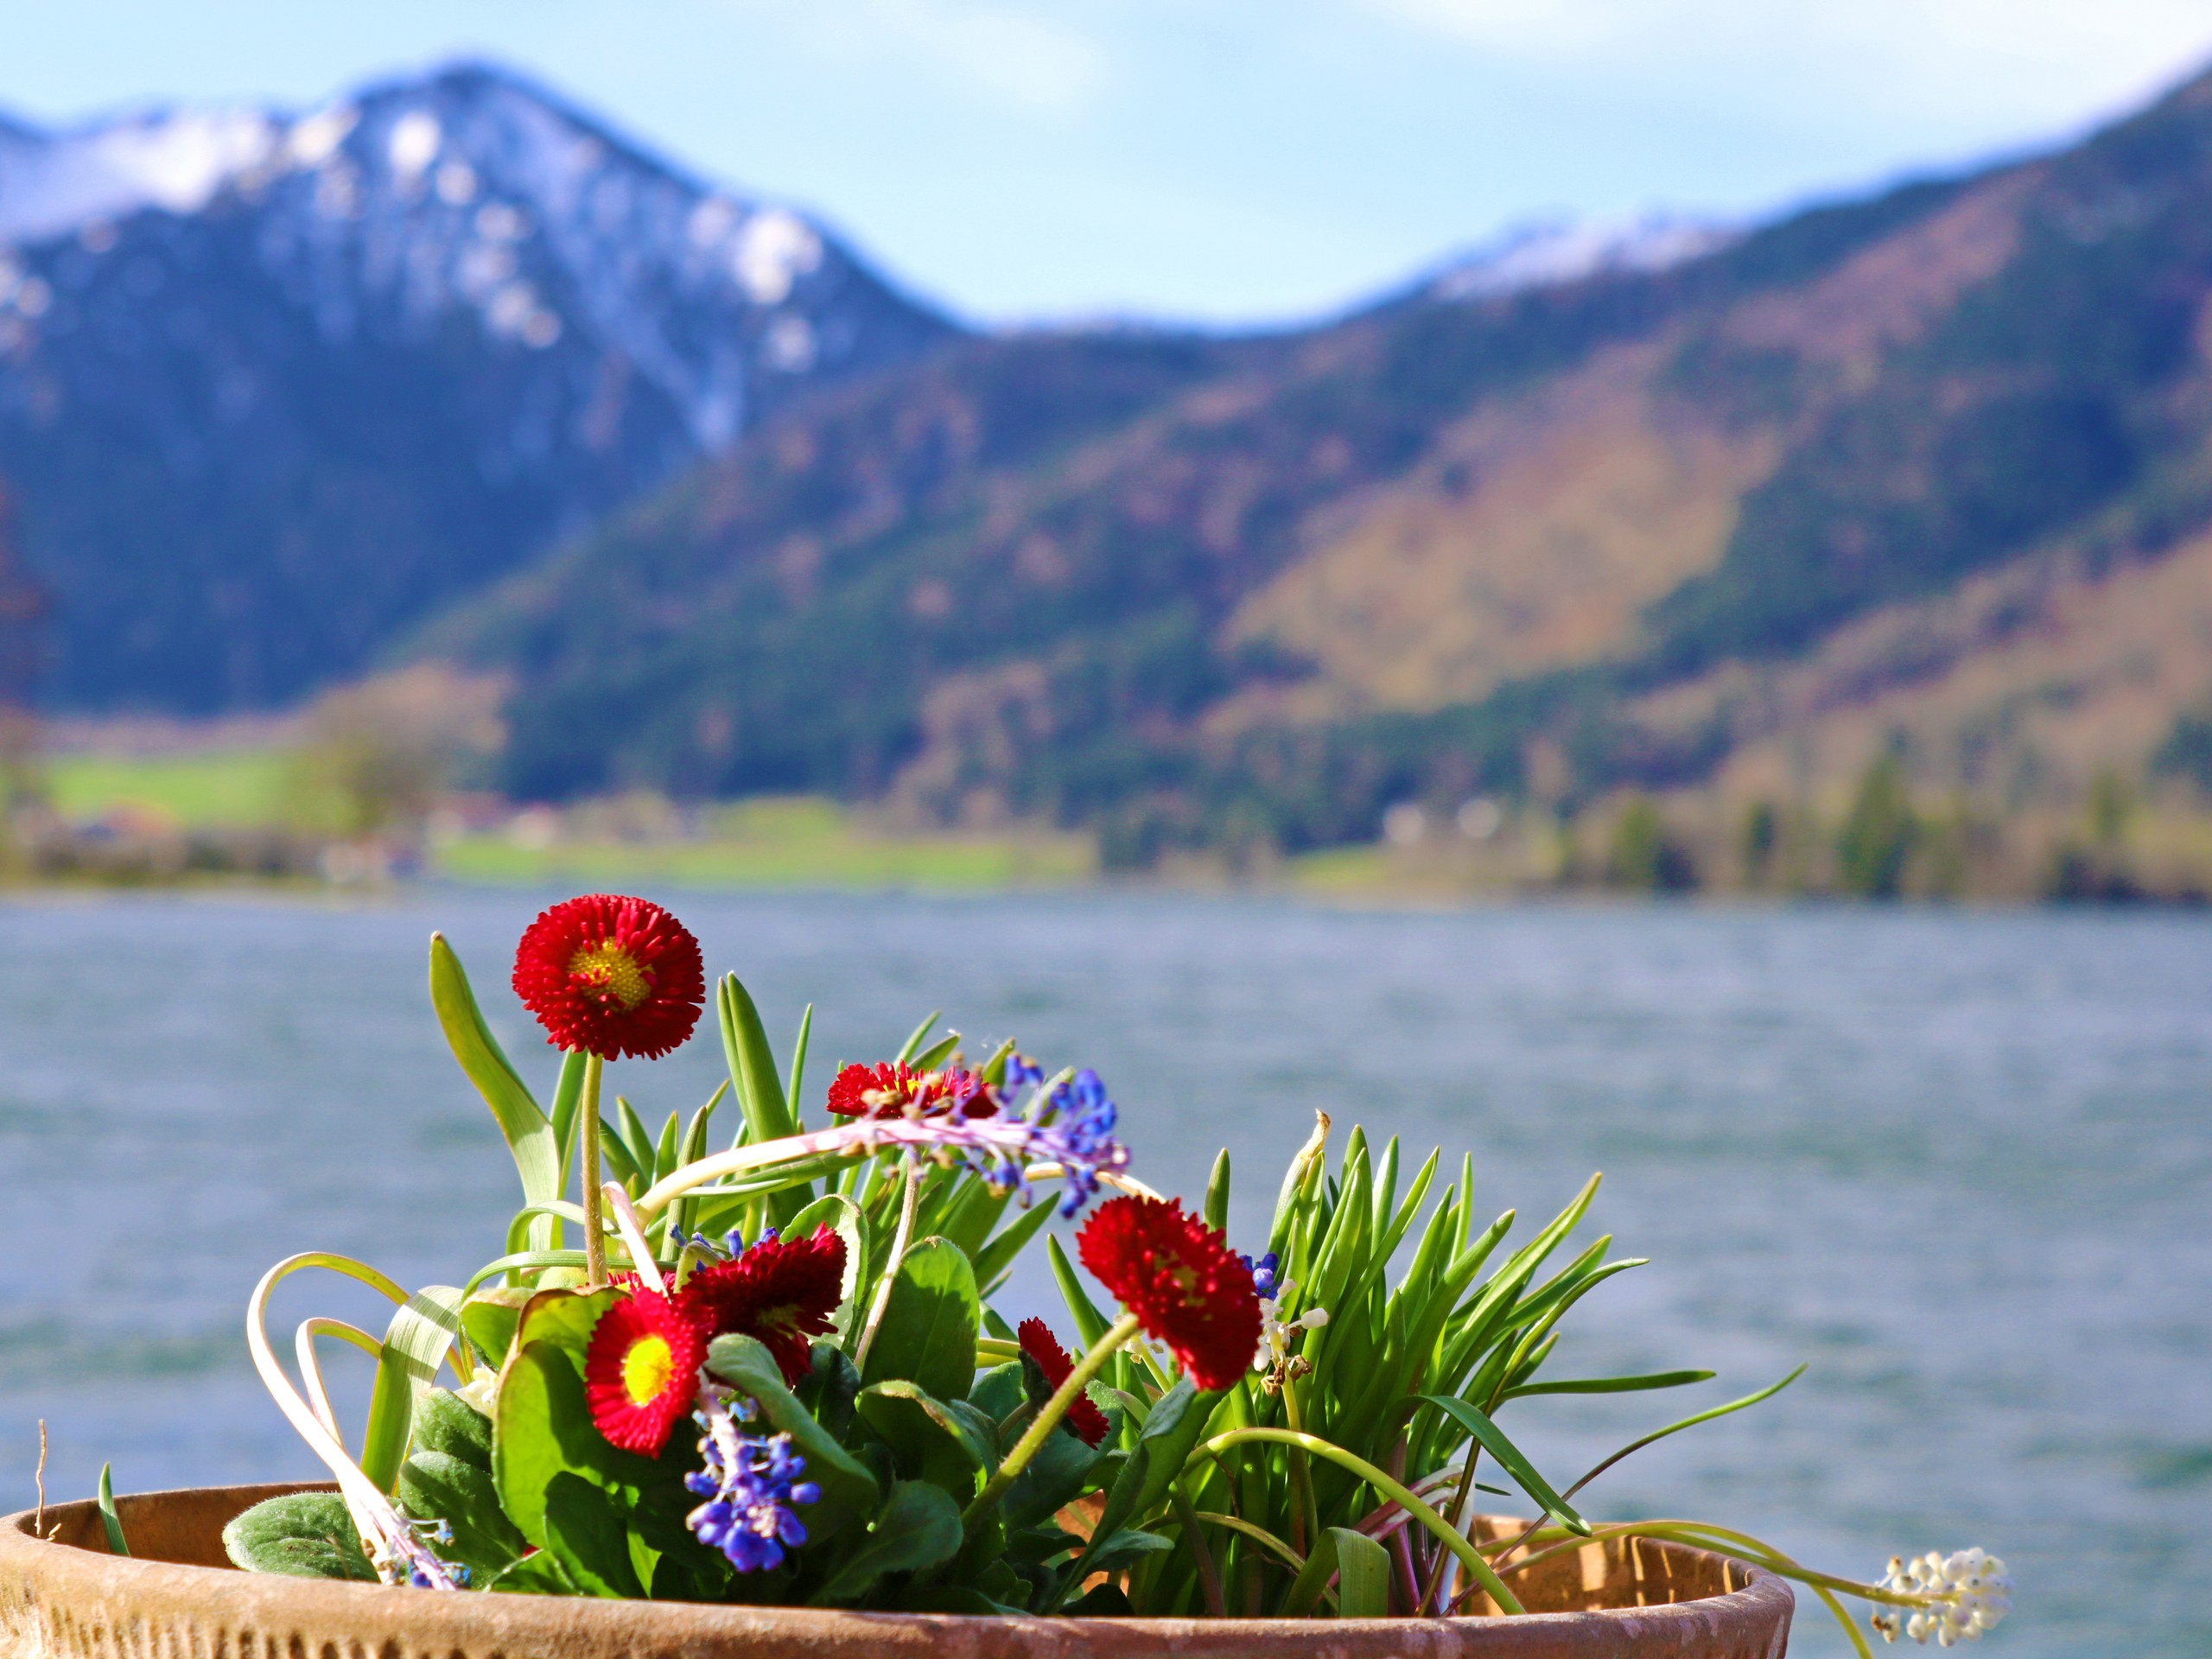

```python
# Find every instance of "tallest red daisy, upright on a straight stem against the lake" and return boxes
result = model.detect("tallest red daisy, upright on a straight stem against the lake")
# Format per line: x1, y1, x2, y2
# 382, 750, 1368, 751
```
515, 893, 706, 1059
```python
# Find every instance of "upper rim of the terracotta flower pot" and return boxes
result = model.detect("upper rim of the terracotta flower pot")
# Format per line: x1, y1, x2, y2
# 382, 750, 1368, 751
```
0, 1482, 1796, 1659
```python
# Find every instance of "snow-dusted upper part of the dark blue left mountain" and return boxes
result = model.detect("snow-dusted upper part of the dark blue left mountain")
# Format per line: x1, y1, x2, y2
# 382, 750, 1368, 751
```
0, 67, 949, 449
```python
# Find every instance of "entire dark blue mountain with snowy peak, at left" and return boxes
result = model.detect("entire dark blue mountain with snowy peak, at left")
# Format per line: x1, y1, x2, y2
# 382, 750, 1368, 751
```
0, 64, 963, 712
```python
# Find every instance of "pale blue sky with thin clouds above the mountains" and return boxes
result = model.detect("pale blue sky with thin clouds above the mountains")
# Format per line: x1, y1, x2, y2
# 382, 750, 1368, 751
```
0, 0, 2212, 323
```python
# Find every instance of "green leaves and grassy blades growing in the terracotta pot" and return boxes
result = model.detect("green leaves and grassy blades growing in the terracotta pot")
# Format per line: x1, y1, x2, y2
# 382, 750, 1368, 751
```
246, 953, 1814, 1617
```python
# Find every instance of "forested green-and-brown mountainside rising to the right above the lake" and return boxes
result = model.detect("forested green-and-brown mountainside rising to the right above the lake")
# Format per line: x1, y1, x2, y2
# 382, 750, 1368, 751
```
417, 58, 2212, 861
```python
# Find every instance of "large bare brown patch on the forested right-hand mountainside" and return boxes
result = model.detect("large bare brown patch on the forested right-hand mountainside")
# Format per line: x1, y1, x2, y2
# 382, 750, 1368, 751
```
1228, 168, 2035, 716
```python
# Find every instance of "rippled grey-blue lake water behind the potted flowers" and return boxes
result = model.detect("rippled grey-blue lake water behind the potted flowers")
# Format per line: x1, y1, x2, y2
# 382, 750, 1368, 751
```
0, 889, 2212, 1659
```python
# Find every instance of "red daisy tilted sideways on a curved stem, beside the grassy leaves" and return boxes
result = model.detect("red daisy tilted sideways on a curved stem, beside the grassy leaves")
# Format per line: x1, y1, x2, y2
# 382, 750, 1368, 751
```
1075, 1199, 1261, 1389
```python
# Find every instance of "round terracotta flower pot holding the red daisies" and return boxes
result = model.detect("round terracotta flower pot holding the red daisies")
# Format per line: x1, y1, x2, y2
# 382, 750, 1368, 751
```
0, 1486, 1794, 1659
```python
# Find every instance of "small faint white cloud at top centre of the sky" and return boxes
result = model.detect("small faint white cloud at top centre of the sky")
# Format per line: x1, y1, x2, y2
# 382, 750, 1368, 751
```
763, 0, 1109, 113
